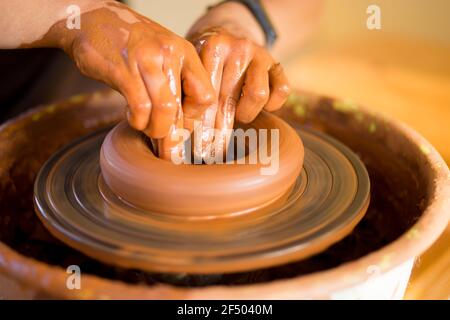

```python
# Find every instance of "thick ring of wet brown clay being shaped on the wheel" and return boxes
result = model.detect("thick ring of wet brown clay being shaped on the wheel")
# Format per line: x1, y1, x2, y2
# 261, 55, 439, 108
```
100, 112, 304, 217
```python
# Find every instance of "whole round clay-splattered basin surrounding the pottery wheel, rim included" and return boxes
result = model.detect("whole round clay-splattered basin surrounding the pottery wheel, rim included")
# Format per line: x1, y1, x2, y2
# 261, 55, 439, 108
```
0, 91, 450, 299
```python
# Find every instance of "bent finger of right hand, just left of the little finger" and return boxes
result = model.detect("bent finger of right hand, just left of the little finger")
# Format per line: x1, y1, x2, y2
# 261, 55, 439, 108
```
236, 58, 270, 123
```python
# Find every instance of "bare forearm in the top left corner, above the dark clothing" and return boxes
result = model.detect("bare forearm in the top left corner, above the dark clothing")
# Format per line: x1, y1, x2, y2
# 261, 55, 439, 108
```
0, 0, 105, 49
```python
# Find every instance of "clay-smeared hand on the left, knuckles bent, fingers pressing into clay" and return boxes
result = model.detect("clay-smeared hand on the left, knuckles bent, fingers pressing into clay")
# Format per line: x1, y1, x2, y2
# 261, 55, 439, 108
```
53, 2, 215, 139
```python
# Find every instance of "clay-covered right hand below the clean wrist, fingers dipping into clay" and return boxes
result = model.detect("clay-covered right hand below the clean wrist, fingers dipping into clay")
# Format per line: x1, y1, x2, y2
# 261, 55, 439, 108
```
189, 27, 290, 159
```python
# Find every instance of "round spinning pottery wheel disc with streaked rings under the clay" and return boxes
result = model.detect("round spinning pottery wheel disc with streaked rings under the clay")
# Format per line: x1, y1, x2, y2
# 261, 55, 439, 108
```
34, 111, 370, 274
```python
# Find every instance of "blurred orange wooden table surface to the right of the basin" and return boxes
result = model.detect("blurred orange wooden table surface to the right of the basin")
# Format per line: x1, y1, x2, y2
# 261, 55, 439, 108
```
285, 37, 450, 299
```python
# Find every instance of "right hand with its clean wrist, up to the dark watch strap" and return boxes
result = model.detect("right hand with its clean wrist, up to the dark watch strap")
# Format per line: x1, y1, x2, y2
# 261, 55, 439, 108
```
187, 2, 290, 156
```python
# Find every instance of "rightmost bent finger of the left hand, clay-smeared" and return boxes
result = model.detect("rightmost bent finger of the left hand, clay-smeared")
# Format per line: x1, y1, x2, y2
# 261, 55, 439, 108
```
181, 46, 215, 131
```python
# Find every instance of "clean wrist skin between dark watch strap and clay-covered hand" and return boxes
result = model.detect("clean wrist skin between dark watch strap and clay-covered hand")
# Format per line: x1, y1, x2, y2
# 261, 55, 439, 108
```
187, 1, 265, 46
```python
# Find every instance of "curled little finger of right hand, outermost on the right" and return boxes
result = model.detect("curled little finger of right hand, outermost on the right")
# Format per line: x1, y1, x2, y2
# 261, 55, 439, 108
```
264, 63, 291, 112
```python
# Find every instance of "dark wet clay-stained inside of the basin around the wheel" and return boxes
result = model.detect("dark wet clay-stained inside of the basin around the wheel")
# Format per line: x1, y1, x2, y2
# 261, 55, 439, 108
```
0, 91, 426, 286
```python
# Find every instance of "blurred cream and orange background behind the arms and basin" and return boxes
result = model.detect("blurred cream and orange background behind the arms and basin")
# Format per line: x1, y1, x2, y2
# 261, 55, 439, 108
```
124, 0, 450, 299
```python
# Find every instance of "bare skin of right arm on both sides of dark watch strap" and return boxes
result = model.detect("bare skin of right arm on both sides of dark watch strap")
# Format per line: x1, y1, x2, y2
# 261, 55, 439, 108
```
188, 0, 322, 59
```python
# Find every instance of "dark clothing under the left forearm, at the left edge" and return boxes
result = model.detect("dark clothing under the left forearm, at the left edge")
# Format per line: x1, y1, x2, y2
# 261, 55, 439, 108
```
0, 49, 104, 123
